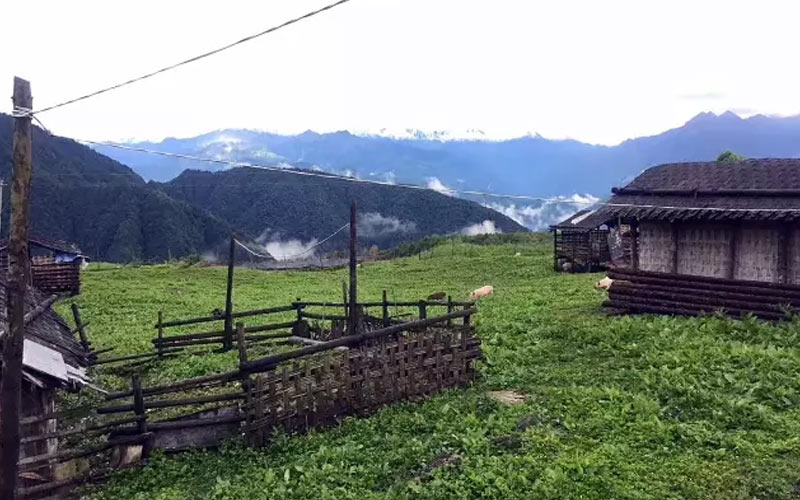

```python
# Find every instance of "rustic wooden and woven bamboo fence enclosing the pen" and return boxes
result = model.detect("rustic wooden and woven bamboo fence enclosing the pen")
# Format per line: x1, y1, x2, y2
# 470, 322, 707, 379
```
19, 300, 480, 498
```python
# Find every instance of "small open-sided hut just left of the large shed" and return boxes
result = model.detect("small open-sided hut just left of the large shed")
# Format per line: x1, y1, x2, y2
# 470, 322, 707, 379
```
550, 209, 611, 272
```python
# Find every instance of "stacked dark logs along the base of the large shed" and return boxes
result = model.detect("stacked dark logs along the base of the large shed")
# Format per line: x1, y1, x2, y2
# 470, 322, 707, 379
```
603, 268, 800, 320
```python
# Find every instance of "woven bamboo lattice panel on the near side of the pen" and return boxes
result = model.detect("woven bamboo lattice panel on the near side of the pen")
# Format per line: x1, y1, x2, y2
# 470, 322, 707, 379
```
242, 327, 480, 446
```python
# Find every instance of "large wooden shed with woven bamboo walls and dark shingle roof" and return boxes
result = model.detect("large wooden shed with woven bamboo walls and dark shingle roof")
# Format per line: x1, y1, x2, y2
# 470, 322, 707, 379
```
598, 159, 800, 318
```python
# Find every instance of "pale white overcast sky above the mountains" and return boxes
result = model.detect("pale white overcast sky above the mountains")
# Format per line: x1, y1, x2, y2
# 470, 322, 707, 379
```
0, 0, 800, 144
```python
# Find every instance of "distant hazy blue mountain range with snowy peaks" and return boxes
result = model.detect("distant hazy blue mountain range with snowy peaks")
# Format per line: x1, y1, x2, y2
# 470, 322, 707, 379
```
98, 111, 800, 229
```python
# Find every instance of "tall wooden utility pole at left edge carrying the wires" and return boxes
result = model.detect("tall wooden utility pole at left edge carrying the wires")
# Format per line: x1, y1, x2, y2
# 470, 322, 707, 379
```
0, 77, 33, 500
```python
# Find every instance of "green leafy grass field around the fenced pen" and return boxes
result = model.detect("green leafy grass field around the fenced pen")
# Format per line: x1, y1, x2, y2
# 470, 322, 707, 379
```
65, 235, 800, 500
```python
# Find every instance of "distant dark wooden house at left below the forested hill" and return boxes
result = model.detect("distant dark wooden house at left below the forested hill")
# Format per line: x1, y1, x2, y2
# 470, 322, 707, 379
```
0, 236, 88, 295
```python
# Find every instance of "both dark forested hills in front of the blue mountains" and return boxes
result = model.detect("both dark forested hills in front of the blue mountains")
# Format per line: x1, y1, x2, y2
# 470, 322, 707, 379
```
0, 114, 524, 262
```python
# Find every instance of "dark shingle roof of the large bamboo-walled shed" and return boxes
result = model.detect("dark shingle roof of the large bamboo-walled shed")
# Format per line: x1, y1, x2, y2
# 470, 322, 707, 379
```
600, 158, 800, 221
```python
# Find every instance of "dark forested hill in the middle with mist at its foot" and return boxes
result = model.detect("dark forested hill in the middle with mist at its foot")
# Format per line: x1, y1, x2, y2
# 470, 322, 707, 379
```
162, 168, 525, 248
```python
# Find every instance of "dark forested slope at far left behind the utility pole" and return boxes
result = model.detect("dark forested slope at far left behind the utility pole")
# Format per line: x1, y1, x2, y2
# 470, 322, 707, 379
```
0, 114, 230, 262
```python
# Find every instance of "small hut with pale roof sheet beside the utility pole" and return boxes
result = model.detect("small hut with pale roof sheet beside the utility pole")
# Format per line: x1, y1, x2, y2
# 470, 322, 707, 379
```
0, 286, 89, 466
